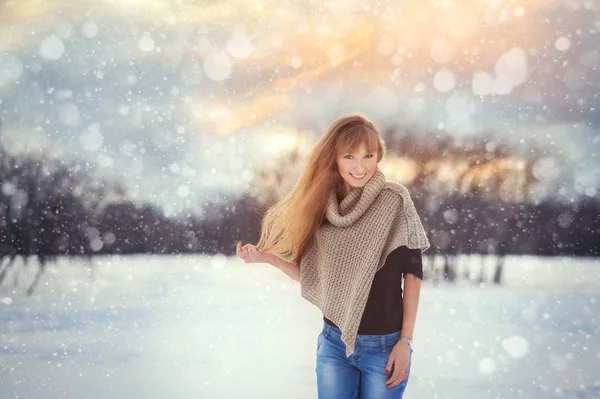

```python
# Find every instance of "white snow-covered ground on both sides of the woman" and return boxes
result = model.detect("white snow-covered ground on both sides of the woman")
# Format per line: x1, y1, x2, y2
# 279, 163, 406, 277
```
0, 256, 600, 399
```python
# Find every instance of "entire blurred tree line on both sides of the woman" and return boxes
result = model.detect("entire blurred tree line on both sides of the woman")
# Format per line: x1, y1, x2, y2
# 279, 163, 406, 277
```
0, 126, 600, 293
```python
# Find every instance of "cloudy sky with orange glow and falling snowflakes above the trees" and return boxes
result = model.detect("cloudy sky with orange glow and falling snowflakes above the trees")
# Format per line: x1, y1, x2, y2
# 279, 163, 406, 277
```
0, 0, 600, 213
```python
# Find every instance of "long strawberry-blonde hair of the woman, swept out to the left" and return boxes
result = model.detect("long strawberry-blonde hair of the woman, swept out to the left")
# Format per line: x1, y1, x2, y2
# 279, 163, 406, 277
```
257, 113, 386, 266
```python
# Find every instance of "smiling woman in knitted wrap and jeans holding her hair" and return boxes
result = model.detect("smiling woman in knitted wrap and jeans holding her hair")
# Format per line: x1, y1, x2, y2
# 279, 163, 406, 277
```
236, 114, 429, 399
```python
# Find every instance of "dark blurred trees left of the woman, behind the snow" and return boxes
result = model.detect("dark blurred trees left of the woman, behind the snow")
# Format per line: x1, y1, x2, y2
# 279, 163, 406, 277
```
0, 147, 264, 294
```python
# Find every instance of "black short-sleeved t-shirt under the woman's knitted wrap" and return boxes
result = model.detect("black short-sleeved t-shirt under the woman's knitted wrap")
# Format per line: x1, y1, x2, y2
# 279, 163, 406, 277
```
323, 245, 423, 335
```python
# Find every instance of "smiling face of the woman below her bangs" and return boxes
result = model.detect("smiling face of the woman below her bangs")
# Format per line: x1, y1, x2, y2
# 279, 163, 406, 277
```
337, 144, 377, 193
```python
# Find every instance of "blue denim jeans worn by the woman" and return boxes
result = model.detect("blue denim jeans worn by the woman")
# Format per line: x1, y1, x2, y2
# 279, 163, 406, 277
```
315, 322, 413, 399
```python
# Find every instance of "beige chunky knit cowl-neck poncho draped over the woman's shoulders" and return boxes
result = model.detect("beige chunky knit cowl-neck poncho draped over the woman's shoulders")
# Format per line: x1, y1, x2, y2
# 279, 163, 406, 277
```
300, 169, 429, 356
